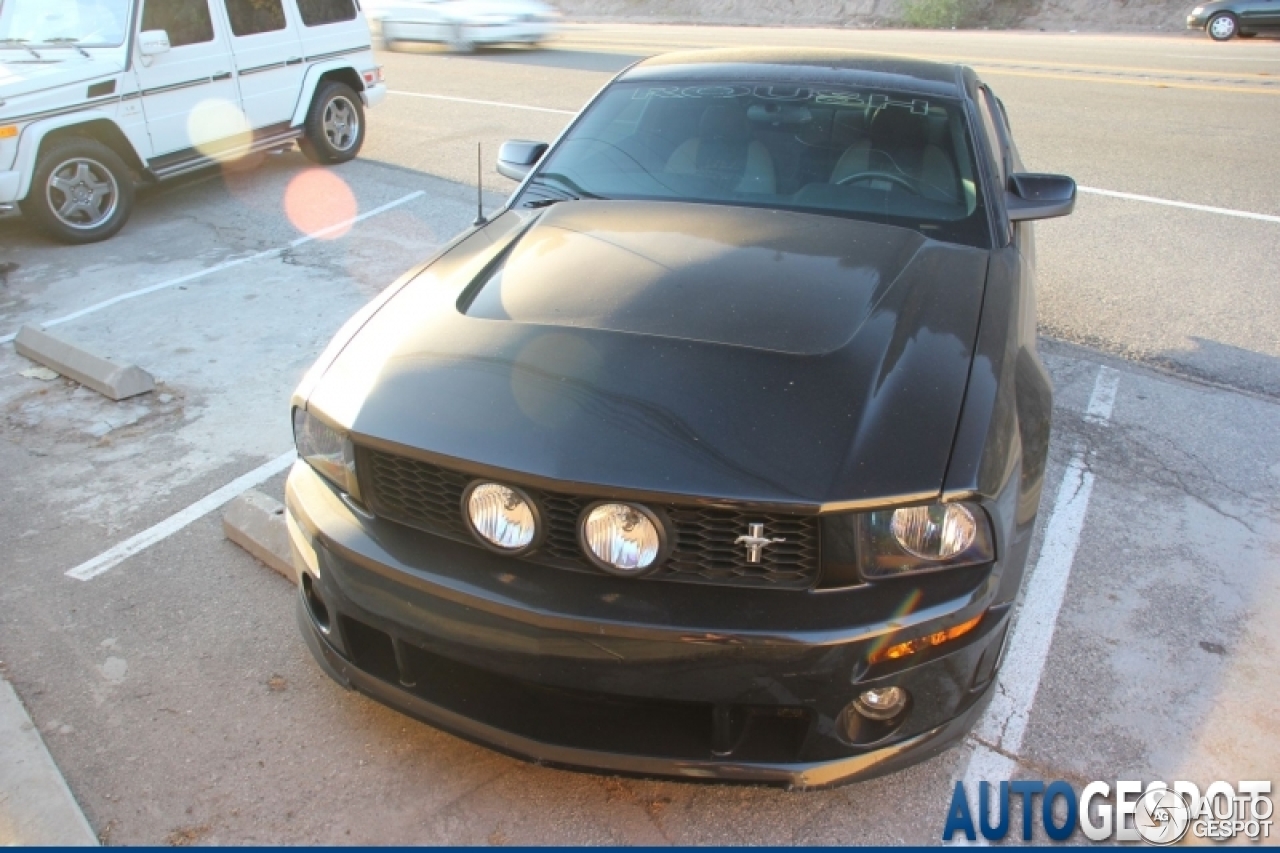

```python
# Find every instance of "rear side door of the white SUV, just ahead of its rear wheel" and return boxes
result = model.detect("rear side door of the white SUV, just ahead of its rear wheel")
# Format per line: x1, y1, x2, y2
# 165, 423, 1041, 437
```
215, 0, 307, 129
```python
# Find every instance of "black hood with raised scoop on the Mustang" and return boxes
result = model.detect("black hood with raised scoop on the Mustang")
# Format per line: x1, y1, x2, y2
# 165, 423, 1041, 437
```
308, 201, 987, 508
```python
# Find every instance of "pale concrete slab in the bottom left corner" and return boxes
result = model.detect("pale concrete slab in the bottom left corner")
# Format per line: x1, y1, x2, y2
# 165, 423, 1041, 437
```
0, 678, 97, 847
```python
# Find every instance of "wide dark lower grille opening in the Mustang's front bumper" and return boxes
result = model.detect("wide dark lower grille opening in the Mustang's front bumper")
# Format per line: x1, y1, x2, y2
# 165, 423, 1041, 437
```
342, 616, 810, 762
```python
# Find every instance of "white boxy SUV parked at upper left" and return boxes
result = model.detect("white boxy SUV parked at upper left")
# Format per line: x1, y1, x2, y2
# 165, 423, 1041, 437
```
0, 0, 387, 243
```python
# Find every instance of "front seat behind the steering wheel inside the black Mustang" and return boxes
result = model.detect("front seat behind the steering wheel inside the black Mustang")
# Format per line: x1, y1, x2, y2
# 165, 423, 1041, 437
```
831, 106, 960, 201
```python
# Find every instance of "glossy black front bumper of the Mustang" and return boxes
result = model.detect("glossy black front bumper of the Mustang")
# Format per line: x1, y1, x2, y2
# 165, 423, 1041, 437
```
287, 462, 1009, 788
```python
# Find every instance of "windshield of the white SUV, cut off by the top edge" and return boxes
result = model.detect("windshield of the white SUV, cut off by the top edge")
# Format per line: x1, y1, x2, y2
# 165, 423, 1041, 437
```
0, 0, 131, 49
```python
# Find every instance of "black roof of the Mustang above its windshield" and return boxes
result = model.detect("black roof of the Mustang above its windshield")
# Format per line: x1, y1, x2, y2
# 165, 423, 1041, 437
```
618, 47, 968, 97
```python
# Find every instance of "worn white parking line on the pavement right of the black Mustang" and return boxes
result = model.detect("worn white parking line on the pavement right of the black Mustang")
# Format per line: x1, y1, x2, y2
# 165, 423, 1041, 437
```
964, 368, 1120, 824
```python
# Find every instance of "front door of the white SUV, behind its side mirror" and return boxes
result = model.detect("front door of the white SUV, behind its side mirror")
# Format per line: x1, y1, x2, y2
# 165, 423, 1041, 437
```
136, 0, 243, 159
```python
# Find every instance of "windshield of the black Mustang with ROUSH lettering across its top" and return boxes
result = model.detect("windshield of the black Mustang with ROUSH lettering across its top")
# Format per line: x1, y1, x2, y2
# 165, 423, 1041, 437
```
521, 82, 991, 247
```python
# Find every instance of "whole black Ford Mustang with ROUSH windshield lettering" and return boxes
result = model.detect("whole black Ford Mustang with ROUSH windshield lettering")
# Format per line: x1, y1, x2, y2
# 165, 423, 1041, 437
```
288, 50, 1075, 786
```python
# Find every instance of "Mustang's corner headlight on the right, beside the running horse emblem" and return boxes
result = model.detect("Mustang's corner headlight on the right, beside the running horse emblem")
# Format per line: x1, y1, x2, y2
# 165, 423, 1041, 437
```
858, 503, 996, 580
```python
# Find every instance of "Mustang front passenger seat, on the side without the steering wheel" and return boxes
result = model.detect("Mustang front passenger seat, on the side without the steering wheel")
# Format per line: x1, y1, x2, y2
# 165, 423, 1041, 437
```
667, 104, 777, 195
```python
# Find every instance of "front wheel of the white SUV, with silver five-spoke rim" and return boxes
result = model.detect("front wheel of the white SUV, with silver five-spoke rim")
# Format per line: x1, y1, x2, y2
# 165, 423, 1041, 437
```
19, 138, 134, 245
